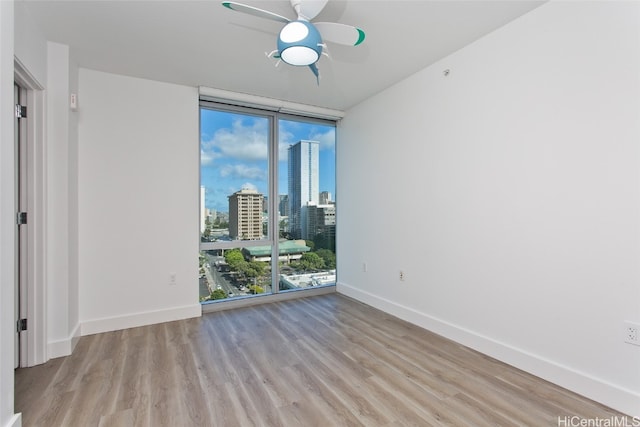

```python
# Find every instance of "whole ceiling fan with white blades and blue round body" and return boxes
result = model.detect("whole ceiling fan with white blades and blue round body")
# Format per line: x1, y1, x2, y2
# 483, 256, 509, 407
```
222, 0, 365, 84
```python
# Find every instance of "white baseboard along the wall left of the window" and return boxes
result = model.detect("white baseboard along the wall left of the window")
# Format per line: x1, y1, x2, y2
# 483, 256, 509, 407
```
80, 303, 202, 336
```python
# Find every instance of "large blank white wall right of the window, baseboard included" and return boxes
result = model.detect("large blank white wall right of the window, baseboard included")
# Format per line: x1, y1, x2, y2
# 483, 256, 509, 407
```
337, 2, 640, 415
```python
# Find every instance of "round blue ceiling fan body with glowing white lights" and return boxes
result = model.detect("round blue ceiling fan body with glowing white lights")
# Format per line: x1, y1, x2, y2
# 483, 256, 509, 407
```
278, 20, 322, 66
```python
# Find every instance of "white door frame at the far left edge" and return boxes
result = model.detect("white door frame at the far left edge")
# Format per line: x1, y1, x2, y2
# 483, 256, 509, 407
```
14, 58, 48, 367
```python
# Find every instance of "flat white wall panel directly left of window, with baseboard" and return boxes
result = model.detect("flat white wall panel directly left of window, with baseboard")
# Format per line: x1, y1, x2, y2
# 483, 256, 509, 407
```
76, 68, 201, 335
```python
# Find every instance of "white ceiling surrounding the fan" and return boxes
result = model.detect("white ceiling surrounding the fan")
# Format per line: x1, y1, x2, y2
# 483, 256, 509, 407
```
19, 0, 543, 110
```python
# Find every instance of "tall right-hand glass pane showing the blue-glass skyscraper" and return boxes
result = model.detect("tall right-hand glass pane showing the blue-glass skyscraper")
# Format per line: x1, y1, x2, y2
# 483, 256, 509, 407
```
278, 119, 336, 290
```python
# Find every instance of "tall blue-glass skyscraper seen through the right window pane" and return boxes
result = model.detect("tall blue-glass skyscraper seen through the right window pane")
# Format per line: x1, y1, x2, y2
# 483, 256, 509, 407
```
289, 140, 320, 239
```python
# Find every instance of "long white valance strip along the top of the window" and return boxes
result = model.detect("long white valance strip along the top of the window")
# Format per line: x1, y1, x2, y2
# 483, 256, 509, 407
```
198, 86, 345, 120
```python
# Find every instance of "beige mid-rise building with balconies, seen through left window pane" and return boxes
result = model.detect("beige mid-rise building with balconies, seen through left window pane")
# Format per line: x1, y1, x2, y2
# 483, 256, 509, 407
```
229, 188, 264, 240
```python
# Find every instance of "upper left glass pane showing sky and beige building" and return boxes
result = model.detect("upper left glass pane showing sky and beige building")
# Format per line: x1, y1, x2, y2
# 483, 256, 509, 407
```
200, 108, 269, 242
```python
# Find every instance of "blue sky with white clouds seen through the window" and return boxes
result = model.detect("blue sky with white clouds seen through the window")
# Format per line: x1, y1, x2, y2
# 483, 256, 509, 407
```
200, 108, 336, 212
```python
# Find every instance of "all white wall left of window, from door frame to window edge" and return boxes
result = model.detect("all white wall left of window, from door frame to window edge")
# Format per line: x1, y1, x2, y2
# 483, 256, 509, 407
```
12, 2, 200, 362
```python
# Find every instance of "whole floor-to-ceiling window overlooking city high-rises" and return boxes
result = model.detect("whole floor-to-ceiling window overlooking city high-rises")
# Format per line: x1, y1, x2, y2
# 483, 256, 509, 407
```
200, 101, 336, 302
